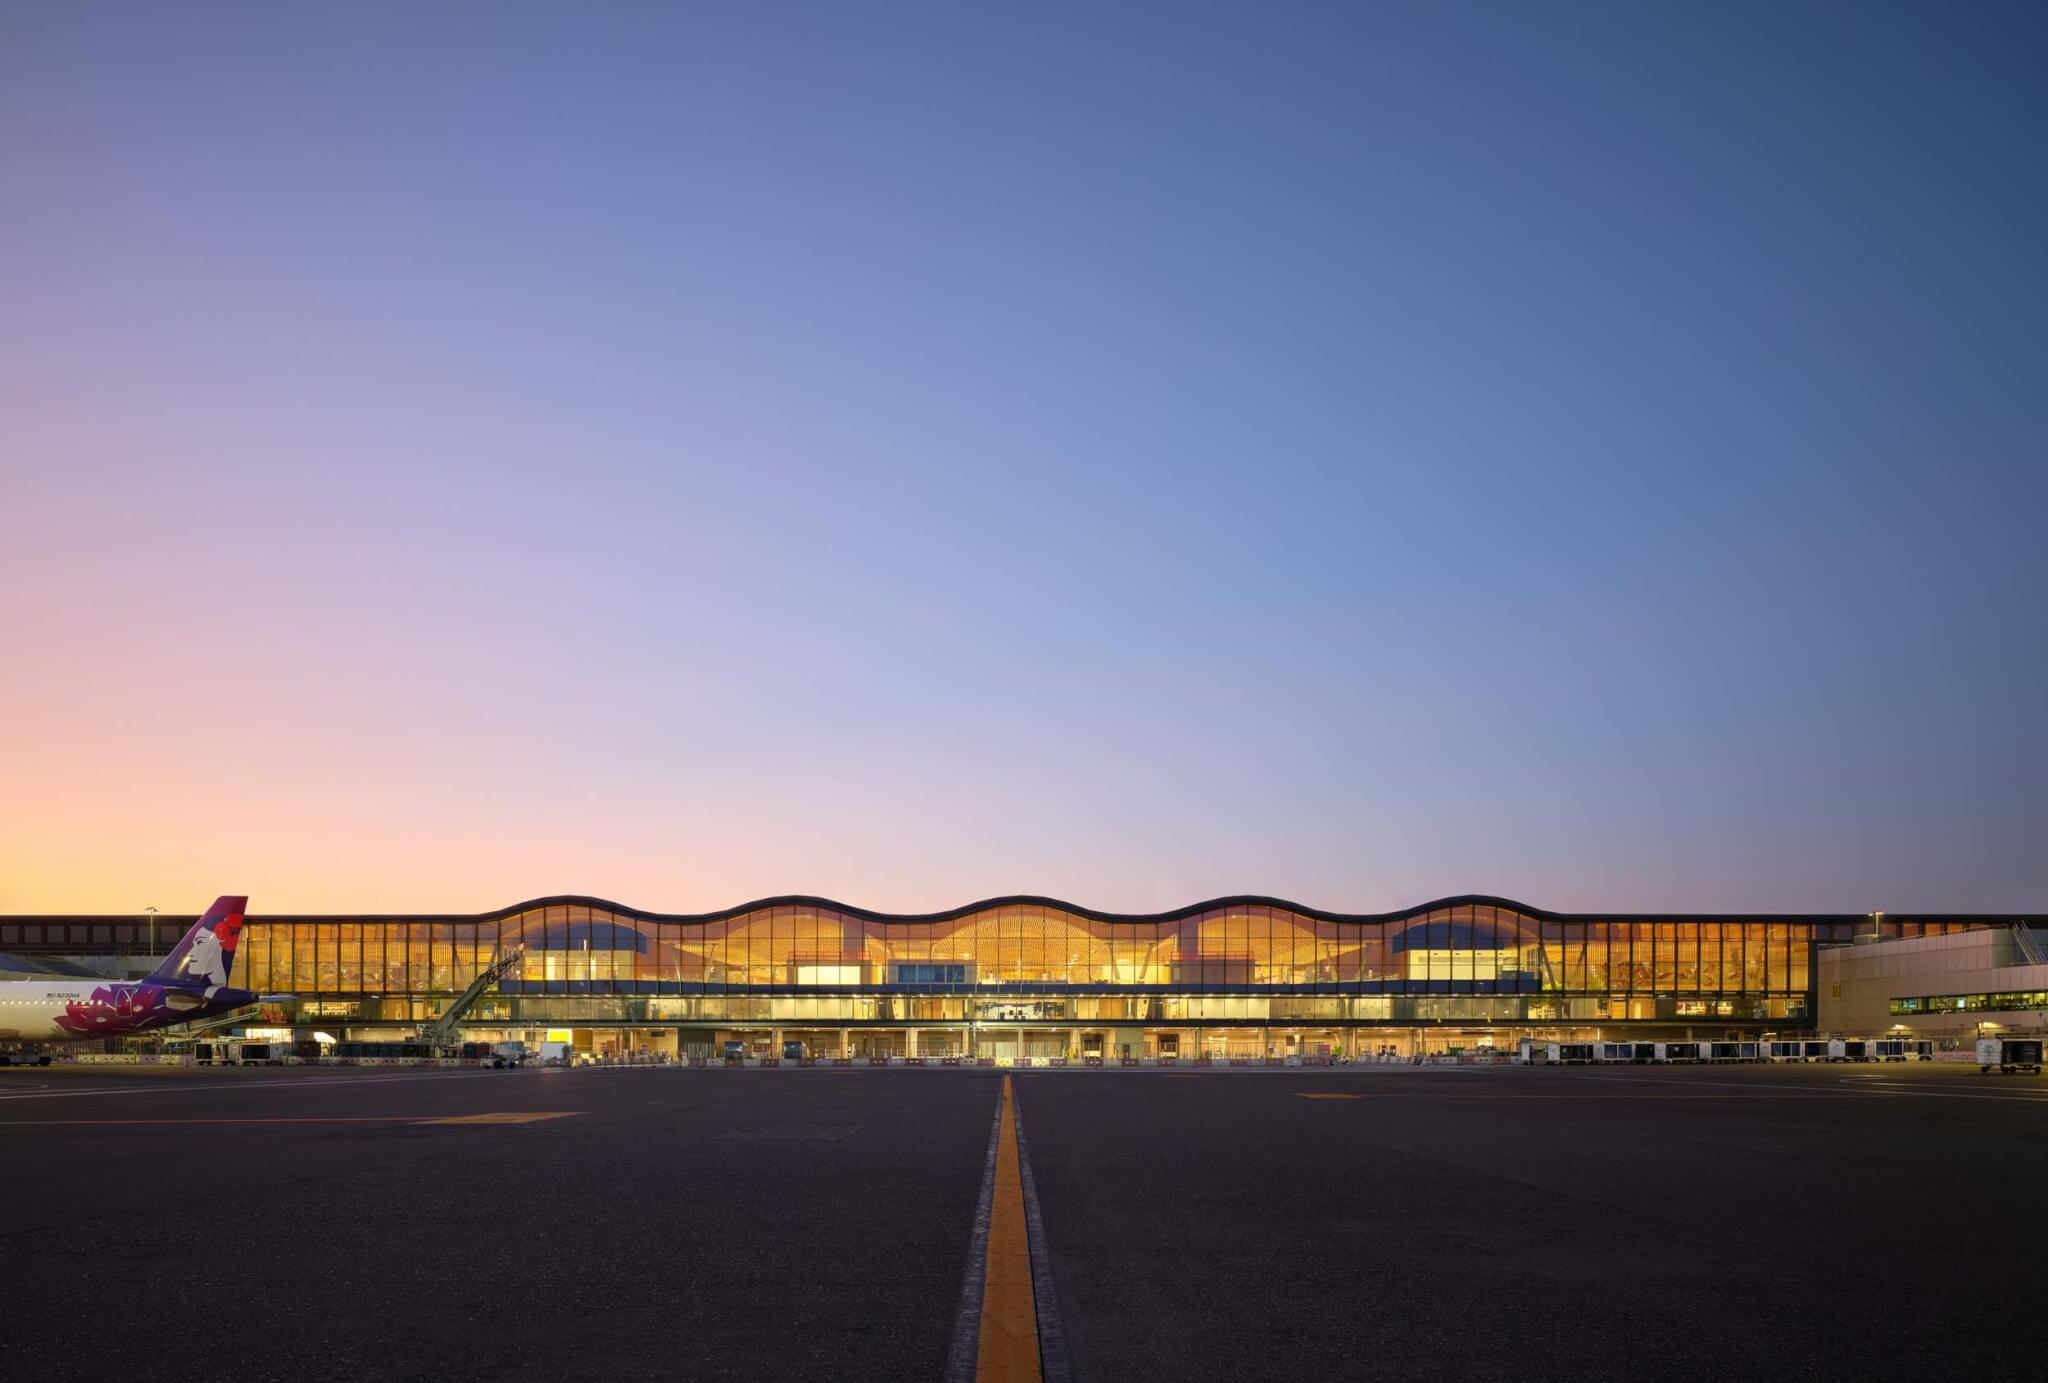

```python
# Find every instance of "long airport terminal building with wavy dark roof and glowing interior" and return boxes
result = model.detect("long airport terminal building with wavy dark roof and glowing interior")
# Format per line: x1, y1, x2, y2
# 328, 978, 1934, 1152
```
0, 895, 2023, 1059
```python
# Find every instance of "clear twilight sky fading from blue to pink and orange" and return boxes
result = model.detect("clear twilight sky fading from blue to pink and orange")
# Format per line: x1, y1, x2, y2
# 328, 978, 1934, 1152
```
0, 0, 2048, 912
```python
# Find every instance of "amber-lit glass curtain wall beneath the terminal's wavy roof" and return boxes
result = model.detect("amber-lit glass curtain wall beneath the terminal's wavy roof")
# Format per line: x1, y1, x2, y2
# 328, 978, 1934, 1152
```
188, 899, 1968, 1045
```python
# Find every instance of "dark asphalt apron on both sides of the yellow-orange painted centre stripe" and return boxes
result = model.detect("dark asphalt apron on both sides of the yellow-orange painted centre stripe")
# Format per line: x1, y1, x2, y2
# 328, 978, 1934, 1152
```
0, 1065, 2048, 1383
